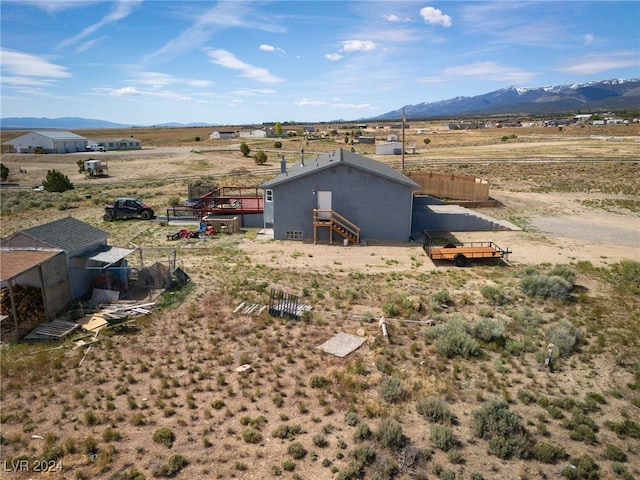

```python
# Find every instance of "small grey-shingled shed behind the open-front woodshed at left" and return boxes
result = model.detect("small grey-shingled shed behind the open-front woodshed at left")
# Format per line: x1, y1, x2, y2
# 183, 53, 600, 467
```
0, 217, 133, 300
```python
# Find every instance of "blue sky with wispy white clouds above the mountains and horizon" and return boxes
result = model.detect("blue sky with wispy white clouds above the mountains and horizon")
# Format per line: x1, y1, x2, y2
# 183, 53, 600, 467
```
0, 0, 640, 125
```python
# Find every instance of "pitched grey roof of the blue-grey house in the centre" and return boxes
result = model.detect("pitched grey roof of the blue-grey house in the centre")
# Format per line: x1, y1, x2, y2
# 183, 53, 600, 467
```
261, 148, 422, 189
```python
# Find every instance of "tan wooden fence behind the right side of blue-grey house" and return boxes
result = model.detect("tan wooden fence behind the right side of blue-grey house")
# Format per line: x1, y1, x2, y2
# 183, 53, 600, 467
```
405, 172, 489, 201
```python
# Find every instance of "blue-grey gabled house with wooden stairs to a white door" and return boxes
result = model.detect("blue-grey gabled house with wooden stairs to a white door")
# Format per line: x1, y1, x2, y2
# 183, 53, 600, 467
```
261, 149, 421, 242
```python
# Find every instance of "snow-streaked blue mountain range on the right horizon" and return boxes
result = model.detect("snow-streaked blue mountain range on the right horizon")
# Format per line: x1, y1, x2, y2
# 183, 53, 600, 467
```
366, 78, 640, 121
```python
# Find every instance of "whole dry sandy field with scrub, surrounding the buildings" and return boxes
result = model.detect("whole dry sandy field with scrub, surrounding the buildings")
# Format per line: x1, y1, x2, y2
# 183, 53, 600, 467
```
0, 124, 640, 480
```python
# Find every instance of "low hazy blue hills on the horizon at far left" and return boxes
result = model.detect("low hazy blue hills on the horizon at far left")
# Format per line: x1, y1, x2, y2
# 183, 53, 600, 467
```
0, 117, 218, 130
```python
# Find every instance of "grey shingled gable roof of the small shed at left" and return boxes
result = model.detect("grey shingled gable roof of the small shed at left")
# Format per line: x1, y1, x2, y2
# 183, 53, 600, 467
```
20, 217, 109, 252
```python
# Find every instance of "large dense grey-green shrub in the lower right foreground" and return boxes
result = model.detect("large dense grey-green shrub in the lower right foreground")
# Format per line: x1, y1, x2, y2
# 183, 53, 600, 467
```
473, 400, 531, 459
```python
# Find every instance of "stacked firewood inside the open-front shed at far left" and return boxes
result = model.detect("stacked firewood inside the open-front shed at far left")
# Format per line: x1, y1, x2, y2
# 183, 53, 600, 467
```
0, 285, 47, 341
